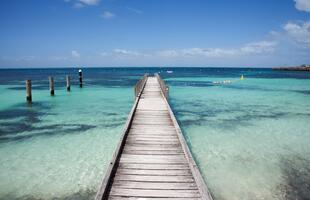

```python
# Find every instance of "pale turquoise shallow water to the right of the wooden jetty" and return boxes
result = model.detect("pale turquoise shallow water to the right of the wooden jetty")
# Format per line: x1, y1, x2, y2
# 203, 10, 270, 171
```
168, 78, 310, 200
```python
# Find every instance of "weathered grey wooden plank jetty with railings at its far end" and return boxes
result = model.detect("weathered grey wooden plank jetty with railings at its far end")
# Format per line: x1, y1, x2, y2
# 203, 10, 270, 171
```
96, 74, 212, 200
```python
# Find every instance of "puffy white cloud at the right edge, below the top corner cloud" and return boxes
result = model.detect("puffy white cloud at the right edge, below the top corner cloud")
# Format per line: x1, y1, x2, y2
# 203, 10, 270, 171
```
283, 21, 310, 46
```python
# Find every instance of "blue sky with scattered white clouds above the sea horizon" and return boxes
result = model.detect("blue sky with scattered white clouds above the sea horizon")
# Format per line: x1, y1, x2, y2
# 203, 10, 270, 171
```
0, 0, 310, 68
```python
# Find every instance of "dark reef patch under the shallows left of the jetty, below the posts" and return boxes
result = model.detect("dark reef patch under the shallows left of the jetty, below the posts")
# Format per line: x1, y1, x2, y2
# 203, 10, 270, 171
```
0, 102, 126, 142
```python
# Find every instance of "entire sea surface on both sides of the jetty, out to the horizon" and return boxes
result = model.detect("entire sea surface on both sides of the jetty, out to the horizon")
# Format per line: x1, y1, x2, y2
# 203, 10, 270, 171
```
0, 67, 310, 200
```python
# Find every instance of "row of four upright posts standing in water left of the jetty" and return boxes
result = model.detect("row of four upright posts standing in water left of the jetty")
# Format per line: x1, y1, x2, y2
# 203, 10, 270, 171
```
26, 69, 83, 102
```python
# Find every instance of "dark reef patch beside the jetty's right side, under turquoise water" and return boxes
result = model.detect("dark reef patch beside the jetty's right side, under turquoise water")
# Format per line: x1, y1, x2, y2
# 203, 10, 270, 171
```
170, 99, 297, 129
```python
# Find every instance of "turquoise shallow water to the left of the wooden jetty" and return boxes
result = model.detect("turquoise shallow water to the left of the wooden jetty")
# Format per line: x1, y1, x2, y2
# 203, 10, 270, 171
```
0, 71, 134, 200
